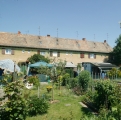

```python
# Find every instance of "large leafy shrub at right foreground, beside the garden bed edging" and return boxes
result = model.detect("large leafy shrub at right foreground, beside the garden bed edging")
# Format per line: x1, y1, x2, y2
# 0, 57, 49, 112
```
94, 80, 117, 110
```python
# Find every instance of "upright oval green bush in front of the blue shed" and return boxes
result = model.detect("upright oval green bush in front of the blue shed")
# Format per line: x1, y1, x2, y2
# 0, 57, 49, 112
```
78, 70, 90, 92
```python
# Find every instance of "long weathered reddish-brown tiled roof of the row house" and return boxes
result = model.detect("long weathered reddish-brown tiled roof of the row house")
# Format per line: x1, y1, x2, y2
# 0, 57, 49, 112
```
0, 32, 113, 53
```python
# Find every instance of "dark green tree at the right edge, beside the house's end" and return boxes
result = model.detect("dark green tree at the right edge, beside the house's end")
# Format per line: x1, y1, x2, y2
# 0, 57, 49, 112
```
111, 35, 121, 65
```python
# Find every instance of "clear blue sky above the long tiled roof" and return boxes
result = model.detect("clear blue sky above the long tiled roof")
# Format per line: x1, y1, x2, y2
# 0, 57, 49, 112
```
0, 0, 121, 47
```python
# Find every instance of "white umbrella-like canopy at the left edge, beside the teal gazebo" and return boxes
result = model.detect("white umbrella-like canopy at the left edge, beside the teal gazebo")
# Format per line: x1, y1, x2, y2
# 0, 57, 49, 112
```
0, 59, 20, 72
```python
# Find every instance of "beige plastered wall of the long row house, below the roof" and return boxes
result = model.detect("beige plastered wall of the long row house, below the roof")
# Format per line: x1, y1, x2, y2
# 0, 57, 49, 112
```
0, 48, 108, 65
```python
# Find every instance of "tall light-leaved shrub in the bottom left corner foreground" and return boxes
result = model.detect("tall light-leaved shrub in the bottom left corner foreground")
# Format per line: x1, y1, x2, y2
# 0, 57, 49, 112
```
0, 81, 27, 120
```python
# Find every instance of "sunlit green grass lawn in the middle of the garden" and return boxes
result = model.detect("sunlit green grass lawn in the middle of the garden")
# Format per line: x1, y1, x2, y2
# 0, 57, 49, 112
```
27, 85, 90, 120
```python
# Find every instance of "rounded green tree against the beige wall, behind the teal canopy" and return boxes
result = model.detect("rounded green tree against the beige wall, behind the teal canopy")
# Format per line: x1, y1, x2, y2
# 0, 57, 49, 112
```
27, 54, 50, 63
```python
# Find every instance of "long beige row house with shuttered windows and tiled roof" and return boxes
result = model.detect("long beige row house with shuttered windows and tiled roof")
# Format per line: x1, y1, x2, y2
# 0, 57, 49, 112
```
0, 32, 113, 65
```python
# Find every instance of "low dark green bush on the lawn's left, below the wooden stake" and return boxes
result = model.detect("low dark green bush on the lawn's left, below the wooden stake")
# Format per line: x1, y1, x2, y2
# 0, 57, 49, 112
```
28, 96, 49, 116
